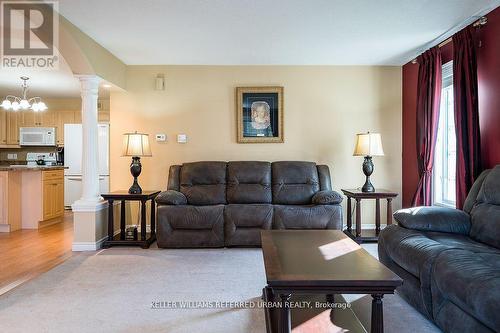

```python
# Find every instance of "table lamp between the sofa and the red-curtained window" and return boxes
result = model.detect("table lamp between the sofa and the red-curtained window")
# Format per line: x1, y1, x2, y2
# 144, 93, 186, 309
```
353, 132, 384, 192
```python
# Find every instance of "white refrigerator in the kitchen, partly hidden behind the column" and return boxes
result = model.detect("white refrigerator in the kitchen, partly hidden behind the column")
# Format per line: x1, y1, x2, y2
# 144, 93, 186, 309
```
64, 124, 109, 207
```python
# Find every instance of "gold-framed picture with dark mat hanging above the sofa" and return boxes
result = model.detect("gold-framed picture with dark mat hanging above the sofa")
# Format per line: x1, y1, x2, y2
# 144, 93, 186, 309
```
236, 87, 284, 143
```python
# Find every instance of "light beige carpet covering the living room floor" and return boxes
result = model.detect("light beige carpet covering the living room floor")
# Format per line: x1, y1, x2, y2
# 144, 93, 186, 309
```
0, 246, 438, 333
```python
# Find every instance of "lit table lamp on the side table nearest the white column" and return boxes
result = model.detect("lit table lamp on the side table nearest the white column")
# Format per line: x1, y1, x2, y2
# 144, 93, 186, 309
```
122, 132, 152, 194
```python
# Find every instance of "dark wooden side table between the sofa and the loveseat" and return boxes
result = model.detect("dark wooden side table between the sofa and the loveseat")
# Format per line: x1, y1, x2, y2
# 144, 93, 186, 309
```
342, 188, 398, 243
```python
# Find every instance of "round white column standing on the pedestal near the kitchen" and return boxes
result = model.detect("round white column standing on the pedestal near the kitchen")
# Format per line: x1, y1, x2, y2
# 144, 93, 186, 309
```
73, 75, 102, 210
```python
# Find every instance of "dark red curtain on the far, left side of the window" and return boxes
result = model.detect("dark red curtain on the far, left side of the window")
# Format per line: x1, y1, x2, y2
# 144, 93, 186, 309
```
412, 46, 442, 206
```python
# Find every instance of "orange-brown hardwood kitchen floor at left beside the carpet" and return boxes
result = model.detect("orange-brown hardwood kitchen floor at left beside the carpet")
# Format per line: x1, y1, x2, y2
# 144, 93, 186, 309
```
0, 211, 73, 295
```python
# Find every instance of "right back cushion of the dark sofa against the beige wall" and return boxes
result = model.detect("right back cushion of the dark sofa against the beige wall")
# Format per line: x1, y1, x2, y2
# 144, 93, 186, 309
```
271, 162, 319, 205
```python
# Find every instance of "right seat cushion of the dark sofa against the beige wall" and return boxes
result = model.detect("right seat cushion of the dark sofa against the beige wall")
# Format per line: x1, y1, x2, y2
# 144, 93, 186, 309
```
273, 205, 342, 230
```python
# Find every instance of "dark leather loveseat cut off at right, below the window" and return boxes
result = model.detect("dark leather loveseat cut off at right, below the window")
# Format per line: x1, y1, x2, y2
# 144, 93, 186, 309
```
378, 165, 500, 333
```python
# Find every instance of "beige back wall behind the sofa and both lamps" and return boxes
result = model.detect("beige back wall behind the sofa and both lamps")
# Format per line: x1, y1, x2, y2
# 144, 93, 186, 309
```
110, 66, 401, 223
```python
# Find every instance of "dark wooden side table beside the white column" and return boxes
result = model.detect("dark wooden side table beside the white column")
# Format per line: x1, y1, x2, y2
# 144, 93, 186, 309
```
101, 190, 160, 249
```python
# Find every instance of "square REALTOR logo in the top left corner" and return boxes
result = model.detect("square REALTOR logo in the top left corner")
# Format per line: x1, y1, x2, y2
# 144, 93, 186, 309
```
0, 1, 59, 70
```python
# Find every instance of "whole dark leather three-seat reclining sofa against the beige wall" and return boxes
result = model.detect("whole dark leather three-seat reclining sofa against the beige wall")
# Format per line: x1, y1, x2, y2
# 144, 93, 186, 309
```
156, 161, 342, 248
